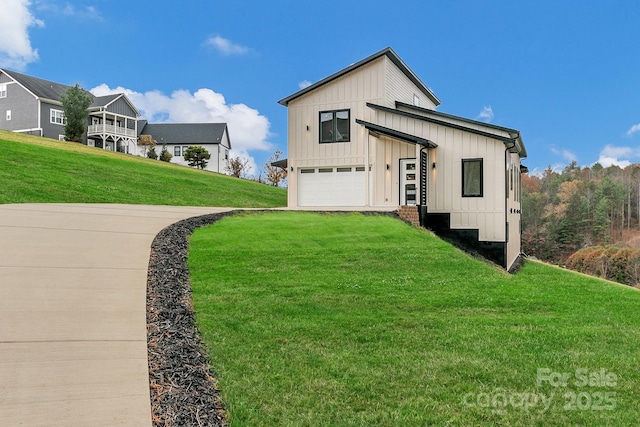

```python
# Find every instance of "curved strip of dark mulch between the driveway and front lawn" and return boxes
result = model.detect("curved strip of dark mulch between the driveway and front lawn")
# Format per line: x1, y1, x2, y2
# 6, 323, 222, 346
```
147, 213, 231, 426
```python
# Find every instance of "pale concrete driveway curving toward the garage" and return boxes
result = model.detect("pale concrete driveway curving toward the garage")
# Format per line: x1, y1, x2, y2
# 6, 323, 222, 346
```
0, 204, 229, 427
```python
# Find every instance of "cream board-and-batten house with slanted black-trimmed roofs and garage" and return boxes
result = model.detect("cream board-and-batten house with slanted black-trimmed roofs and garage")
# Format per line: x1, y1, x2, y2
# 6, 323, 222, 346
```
279, 48, 527, 269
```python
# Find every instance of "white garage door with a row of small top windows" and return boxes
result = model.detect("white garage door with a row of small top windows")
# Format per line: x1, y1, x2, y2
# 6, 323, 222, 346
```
298, 166, 366, 206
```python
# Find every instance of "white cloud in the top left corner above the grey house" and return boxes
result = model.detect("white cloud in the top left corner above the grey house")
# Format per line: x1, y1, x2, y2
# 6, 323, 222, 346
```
0, 0, 44, 70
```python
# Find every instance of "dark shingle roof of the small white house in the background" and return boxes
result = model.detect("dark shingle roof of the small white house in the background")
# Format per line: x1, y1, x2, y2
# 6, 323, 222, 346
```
138, 120, 227, 148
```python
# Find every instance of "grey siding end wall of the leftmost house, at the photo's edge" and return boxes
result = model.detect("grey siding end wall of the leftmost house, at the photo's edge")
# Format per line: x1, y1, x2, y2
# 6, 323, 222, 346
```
0, 81, 40, 130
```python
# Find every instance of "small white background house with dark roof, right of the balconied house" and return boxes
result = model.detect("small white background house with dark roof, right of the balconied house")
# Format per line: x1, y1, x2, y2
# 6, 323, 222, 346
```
138, 120, 231, 173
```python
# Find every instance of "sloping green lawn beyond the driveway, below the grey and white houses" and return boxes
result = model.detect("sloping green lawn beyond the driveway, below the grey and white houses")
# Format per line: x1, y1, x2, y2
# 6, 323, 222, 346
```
0, 131, 287, 207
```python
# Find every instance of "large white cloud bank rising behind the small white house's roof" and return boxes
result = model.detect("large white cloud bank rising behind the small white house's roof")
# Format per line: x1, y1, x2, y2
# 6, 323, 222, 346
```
90, 83, 273, 175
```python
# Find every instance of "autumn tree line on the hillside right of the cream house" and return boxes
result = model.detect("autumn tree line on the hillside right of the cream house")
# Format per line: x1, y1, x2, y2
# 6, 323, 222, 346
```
522, 162, 640, 284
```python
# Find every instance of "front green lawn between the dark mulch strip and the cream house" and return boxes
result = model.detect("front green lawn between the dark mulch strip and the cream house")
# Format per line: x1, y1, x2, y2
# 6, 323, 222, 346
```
189, 212, 640, 426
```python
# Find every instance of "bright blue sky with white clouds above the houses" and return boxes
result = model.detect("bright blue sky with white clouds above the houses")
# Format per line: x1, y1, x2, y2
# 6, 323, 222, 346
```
0, 0, 640, 176
